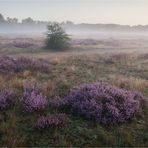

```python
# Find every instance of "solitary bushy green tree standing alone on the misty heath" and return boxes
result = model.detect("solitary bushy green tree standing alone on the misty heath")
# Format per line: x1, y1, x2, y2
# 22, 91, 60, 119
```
45, 23, 70, 50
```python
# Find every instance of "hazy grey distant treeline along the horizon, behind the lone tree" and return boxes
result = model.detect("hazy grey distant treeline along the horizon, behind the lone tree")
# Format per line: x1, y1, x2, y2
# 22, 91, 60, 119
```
0, 14, 148, 32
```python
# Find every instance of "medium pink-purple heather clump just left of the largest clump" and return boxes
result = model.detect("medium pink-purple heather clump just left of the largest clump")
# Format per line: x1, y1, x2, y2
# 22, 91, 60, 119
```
22, 86, 48, 112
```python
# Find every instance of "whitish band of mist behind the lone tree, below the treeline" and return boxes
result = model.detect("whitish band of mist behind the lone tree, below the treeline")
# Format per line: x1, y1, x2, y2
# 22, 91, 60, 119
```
0, 22, 148, 38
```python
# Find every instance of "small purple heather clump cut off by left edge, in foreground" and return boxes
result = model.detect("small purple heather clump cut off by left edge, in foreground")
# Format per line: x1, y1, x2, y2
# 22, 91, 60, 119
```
0, 90, 14, 109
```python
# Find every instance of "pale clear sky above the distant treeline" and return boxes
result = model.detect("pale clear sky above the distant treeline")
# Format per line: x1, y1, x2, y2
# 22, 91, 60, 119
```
0, 0, 148, 25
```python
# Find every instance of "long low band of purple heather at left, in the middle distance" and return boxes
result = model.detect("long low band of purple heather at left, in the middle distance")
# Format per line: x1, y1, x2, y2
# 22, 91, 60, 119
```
0, 56, 51, 73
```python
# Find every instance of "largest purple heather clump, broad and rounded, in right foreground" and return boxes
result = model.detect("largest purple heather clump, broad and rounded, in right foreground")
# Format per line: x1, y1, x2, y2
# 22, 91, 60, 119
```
51, 82, 144, 124
